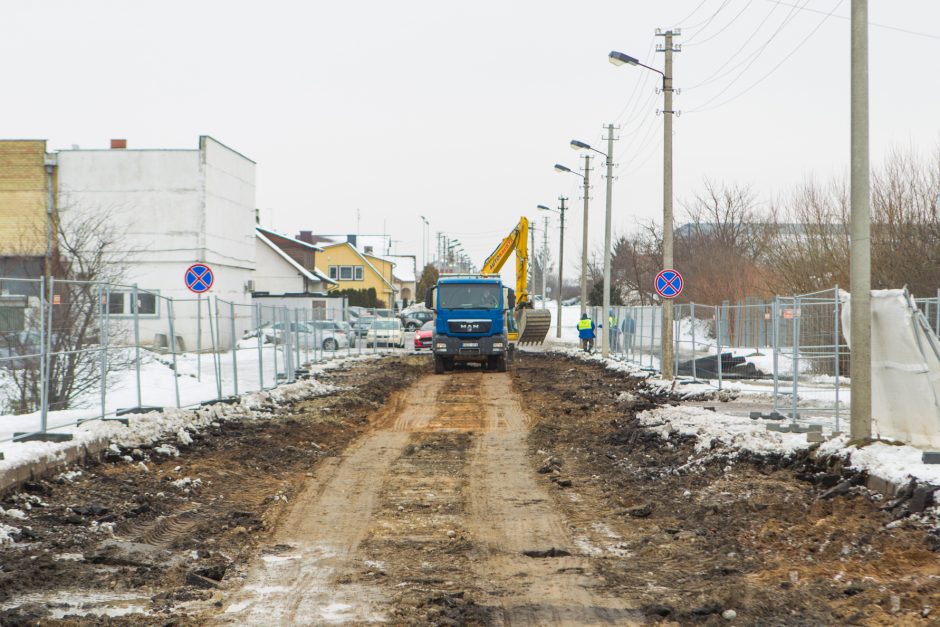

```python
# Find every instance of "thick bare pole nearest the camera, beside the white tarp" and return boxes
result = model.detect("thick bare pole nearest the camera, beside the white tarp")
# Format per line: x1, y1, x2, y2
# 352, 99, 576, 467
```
849, 0, 871, 440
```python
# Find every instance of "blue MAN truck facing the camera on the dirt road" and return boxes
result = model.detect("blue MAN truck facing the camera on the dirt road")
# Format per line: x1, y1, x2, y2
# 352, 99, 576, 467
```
424, 275, 516, 374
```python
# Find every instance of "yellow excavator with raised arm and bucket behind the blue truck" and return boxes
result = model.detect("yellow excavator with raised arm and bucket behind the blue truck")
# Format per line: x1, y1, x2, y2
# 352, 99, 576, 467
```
482, 216, 552, 345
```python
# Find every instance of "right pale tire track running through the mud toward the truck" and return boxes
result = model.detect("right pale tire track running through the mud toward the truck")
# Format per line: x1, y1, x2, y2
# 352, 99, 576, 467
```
467, 374, 642, 625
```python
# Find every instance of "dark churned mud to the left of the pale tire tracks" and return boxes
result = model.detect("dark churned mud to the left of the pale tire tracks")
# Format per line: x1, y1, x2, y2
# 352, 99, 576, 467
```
0, 357, 429, 625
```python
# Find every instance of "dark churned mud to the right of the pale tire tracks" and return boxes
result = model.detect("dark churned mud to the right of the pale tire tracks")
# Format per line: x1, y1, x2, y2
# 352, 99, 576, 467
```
513, 356, 940, 625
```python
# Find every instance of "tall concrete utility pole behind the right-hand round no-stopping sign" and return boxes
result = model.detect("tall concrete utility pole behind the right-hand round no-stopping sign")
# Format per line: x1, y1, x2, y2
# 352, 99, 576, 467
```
656, 30, 679, 379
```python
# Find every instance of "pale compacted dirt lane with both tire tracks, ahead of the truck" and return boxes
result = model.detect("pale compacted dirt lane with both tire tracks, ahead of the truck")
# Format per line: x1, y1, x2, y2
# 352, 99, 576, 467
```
220, 372, 639, 625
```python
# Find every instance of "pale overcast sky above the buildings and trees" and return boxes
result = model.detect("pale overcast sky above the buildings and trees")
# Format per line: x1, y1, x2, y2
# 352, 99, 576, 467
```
0, 0, 940, 280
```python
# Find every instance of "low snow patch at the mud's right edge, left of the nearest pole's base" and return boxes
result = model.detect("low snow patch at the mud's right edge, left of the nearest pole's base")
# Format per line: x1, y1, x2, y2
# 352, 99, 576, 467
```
637, 406, 809, 455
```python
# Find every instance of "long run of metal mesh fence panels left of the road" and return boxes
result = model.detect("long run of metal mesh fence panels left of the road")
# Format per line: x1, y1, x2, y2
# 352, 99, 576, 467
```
0, 277, 413, 441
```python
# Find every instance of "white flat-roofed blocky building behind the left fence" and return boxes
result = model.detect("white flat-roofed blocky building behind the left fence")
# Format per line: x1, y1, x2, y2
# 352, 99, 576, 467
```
58, 136, 256, 350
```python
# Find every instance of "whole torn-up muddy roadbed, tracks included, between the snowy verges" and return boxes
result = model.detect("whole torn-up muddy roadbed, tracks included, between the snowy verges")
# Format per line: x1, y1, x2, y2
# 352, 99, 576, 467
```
0, 354, 940, 625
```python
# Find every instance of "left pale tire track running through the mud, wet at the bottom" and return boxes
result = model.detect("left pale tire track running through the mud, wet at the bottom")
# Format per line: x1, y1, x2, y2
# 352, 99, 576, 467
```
218, 377, 444, 625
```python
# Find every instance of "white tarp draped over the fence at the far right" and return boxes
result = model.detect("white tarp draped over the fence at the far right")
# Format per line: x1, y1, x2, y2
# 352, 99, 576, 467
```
842, 290, 940, 449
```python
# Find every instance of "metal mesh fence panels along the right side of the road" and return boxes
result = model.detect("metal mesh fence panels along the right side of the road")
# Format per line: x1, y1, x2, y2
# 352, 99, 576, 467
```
588, 288, 852, 430
